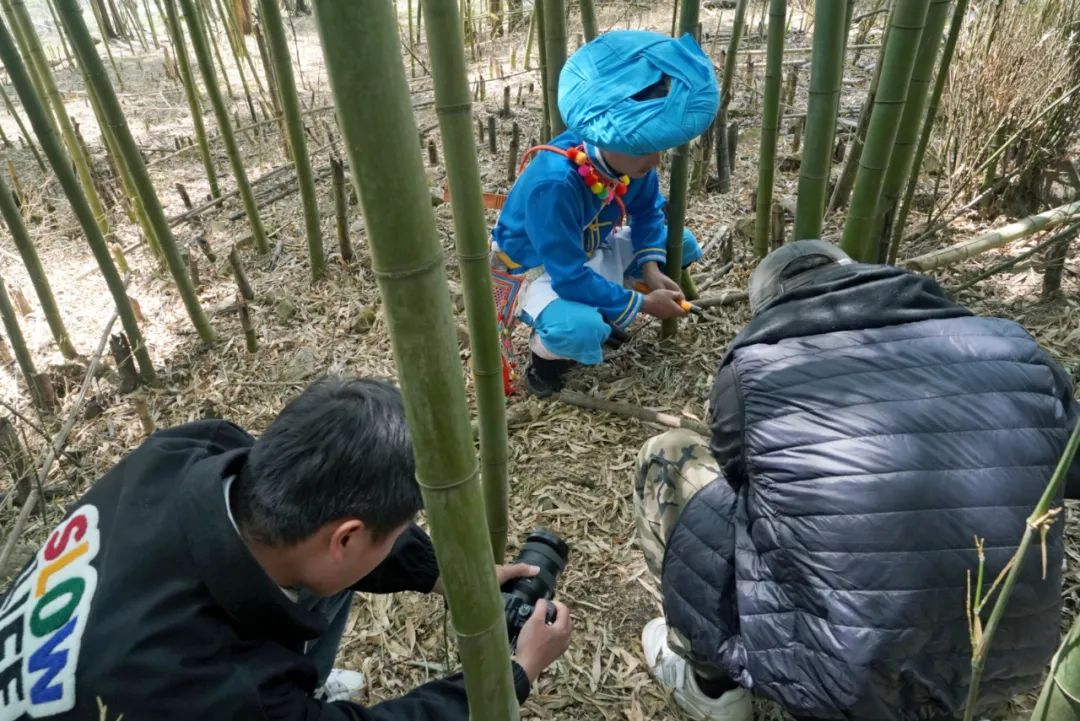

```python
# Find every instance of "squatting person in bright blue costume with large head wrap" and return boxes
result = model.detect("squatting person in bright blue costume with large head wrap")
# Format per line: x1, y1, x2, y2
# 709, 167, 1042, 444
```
491, 30, 719, 395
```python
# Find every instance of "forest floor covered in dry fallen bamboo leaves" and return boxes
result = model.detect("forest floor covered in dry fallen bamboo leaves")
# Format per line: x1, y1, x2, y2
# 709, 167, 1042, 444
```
0, 2, 1080, 721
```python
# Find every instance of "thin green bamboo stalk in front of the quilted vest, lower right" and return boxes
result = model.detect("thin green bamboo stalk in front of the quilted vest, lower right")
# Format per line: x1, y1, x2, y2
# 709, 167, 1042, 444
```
963, 423, 1080, 721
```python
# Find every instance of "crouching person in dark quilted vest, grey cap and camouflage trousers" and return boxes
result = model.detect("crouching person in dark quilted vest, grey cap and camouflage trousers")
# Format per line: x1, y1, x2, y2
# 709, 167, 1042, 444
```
635, 241, 1080, 721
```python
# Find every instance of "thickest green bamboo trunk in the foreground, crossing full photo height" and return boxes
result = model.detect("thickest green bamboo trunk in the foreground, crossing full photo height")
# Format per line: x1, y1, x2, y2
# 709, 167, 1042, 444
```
314, 0, 518, 721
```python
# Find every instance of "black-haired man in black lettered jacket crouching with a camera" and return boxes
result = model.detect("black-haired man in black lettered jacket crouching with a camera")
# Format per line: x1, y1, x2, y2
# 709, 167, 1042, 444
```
0, 379, 570, 721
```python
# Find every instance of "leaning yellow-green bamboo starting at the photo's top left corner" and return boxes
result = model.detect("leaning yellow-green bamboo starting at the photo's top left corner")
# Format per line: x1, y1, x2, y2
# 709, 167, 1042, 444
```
0, 0, 111, 236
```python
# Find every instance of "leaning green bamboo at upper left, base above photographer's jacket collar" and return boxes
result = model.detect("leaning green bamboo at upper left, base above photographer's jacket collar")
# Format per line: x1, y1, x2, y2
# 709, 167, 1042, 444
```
56, 0, 217, 343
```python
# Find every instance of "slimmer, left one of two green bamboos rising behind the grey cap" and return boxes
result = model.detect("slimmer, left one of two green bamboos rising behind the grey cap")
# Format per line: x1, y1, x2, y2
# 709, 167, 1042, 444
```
754, 0, 787, 258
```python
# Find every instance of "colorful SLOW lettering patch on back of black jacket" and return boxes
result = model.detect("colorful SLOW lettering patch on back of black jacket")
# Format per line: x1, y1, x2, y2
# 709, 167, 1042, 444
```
0, 505, 100, 721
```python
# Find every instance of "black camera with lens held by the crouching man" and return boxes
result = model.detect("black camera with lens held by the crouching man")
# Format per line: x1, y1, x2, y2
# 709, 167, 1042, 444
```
501, 528, 570, 650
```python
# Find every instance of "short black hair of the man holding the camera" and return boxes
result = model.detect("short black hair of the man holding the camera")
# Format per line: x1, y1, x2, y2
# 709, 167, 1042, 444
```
230, 377, 422, 546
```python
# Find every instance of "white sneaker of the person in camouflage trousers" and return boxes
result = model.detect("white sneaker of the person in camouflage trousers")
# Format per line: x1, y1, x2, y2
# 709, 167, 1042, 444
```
642, 616, 754, 721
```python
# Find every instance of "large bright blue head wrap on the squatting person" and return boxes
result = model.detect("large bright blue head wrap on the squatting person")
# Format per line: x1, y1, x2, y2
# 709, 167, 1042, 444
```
558, 30, 719, 155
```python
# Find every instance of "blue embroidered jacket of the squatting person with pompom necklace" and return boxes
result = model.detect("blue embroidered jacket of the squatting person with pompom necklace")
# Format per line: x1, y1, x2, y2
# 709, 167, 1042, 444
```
492, 132, 667, 327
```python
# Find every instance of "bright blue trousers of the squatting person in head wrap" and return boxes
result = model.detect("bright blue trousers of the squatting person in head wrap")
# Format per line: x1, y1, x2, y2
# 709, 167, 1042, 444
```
522, 229, 701, 366
